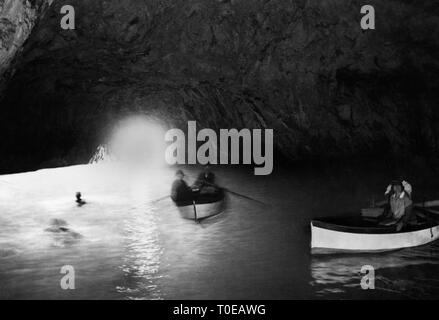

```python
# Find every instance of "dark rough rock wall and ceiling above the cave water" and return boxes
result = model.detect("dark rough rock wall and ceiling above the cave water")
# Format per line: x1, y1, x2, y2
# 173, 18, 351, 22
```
0, 0, 439, 170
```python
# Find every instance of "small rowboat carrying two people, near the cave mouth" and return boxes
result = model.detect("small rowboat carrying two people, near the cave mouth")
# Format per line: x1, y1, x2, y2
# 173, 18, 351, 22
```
175, 188, 225, 221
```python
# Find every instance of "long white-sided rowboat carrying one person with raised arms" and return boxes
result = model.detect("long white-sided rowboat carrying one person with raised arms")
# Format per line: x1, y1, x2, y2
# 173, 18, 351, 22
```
311, 205, 439, 254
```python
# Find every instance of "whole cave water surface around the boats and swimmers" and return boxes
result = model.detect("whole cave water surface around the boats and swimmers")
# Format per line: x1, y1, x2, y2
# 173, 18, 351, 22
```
0, 161, 439, 299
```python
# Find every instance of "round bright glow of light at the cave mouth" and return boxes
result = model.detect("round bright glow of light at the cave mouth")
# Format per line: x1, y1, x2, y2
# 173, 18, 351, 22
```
108, 116, 166, 166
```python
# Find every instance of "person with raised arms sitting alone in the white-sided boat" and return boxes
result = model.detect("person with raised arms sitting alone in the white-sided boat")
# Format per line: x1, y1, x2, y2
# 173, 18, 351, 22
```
382, 180, 413, 231
